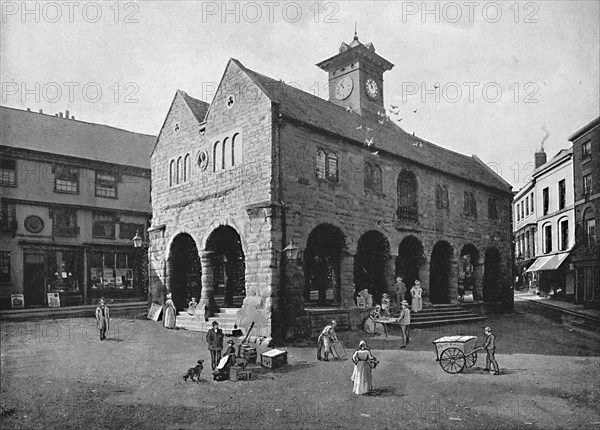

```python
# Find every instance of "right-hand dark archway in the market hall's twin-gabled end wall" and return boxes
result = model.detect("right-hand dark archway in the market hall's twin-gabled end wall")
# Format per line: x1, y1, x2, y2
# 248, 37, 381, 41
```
206, 225, 246, 307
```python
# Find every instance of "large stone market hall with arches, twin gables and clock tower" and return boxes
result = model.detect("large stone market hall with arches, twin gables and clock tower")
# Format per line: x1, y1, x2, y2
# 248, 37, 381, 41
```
149, 38, 513, 338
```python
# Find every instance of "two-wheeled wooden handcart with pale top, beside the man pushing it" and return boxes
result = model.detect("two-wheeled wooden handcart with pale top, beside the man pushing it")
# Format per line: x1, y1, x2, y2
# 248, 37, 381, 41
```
433, 336, 477, 373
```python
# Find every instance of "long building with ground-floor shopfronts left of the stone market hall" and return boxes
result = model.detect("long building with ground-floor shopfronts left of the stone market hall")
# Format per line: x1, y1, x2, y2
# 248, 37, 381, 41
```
0, 107, 155, 309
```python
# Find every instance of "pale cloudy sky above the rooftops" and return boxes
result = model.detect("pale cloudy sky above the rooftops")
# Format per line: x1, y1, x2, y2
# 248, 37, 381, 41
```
0, 0, 600, 190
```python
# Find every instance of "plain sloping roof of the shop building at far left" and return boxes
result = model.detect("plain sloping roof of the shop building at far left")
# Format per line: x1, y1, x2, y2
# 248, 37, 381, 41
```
0, 106, 156, 169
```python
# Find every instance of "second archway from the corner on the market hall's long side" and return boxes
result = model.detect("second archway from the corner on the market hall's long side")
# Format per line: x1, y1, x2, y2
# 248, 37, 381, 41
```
354, 230, 390, 303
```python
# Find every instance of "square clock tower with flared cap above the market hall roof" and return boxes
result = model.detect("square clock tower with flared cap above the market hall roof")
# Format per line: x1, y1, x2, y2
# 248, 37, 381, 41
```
317, 34, 394, 117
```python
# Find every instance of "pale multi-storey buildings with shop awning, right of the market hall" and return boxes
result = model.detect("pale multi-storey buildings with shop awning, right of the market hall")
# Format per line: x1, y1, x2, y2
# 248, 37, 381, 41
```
513, 148, 575, 297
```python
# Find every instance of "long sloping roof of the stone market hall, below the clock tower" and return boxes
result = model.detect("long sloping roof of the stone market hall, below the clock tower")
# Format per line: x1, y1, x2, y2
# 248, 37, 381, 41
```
232, 59, 512, 192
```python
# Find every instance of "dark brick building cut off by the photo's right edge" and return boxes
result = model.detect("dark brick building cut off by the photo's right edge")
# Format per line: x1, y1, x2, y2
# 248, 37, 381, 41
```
569, 117, 600, 307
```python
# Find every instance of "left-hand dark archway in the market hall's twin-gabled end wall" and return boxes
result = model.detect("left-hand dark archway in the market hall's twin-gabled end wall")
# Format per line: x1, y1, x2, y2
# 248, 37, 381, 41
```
167, 233, 202, 310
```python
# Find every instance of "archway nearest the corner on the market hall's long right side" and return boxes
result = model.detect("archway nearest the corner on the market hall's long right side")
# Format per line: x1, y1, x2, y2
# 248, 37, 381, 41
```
304, 224, 346, 306
